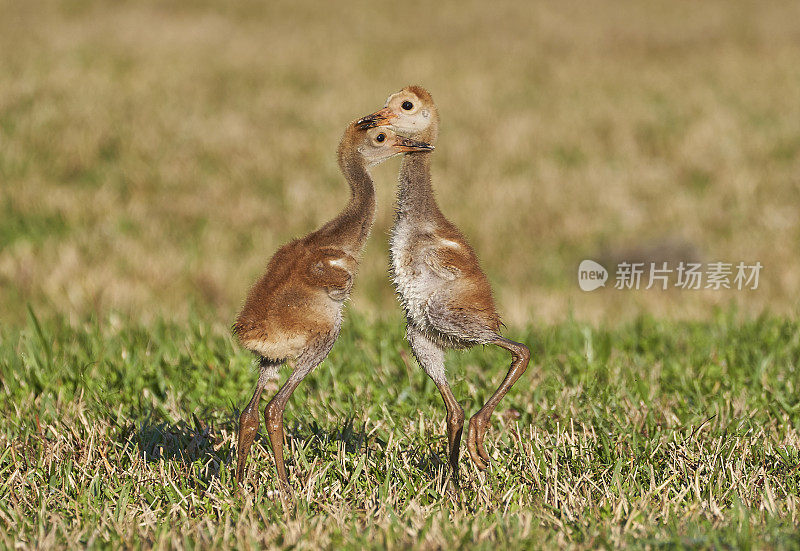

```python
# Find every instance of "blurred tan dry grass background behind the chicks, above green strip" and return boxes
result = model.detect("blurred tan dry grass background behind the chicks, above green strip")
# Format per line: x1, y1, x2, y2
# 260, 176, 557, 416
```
0, 0, 800, 325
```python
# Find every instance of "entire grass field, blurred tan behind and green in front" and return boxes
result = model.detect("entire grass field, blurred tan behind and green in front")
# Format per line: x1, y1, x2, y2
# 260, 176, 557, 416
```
0, 0, 800, 549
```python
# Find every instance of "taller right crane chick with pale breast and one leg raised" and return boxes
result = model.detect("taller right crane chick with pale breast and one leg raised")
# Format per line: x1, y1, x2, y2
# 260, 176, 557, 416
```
358, 86, 530, 480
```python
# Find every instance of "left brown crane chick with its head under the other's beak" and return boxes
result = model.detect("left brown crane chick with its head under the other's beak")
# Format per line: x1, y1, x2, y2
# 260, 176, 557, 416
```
233, 123, 433, 496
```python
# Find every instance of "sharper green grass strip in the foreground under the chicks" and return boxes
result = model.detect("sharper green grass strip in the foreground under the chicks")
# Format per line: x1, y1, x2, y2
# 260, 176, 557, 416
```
0, 312, 800, 549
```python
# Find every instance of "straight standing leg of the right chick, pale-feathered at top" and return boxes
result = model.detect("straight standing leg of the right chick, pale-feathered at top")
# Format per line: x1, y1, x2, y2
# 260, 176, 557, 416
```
406, 327, 464, 481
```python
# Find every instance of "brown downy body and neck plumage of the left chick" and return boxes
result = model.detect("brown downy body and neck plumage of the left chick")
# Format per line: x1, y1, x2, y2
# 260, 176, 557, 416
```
233, 124, 375, 361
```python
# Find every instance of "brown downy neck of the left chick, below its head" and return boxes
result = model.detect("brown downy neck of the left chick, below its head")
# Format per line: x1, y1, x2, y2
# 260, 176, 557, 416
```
318, 151, 375, 251
